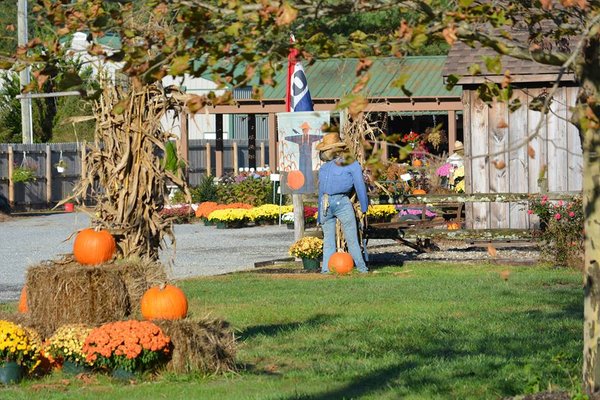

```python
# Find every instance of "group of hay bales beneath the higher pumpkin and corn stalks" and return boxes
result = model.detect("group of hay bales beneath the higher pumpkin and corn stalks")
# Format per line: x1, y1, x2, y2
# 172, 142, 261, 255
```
26, 258, 166, 336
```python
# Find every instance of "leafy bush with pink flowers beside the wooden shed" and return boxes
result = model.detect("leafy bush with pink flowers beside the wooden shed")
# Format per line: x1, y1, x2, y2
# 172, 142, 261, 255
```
528, 196, 584, 268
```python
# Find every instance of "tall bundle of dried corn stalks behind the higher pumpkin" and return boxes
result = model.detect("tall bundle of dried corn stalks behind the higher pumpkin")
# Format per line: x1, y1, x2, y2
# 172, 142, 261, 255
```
72, 85, 189, 260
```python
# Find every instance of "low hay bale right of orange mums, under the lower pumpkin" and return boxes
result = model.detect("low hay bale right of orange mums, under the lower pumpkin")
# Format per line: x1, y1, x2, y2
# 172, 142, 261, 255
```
154, 319, 236, 373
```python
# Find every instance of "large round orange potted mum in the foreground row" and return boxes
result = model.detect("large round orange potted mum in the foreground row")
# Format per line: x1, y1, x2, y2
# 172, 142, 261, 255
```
83, 320, 171, 378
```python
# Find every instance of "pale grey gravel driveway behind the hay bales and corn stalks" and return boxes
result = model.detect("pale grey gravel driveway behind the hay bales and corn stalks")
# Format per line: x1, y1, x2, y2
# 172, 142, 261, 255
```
0, 212, 294, 302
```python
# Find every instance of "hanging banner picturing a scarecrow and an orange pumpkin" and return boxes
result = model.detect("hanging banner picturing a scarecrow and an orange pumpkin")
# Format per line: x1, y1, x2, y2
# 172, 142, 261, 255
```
277, 111, 330, 194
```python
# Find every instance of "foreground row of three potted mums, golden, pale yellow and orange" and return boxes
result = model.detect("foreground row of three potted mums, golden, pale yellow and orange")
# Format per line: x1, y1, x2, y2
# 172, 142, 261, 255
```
0, 320, 171, 384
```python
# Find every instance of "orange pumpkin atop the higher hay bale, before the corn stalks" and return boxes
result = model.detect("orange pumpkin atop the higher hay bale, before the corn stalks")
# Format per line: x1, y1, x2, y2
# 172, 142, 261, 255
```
73, 228, 117, 265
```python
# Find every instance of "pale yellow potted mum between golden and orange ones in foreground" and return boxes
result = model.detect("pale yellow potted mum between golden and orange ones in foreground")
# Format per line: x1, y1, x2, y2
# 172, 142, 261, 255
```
45, 324, 92, 374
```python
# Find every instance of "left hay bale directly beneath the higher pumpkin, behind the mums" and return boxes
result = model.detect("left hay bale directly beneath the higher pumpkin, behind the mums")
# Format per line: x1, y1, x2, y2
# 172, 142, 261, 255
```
26, 262, 130, 336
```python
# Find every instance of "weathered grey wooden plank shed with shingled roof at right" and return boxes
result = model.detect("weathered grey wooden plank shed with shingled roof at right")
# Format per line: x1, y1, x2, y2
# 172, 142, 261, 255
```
443, 43, 583, 229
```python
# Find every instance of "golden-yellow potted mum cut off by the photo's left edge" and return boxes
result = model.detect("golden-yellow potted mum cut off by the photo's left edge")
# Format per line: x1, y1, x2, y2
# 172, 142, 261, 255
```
0, 320, 39, 384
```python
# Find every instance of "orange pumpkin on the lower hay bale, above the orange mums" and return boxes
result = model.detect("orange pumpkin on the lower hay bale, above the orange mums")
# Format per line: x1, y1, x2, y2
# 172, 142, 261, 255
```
141, 285, 187, 320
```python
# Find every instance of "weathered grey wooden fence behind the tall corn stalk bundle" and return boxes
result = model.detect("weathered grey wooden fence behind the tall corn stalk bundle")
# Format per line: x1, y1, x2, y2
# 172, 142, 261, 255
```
0, 140, 269, 210
